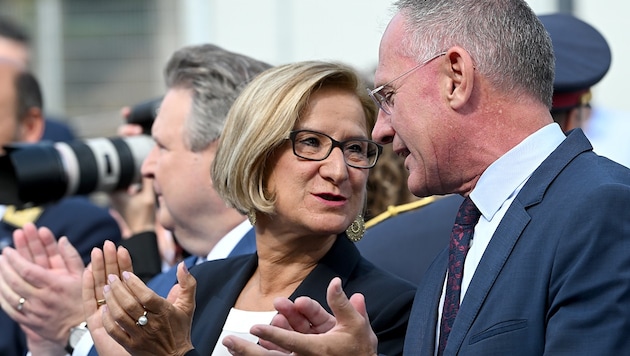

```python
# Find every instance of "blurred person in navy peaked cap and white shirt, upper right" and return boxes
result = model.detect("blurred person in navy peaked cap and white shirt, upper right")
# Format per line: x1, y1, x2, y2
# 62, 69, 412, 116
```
539, 14, 630, 167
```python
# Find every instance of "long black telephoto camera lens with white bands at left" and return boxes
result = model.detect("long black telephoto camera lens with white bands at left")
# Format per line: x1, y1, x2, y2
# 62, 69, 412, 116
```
0, 135, 154, 207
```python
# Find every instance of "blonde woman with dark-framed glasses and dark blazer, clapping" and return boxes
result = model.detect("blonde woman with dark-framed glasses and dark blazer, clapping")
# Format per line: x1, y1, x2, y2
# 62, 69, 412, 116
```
87, 61, 414, 355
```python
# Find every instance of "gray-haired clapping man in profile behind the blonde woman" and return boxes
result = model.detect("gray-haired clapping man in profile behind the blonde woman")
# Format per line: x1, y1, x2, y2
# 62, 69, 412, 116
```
3, 45, 270, 355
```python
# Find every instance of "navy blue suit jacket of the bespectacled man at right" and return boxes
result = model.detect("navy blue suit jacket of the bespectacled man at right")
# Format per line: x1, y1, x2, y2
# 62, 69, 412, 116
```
404, 129, 630, 356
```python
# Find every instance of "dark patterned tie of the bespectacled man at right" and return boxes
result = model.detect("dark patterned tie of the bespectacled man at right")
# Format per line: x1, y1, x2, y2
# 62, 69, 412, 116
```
438, 197, 481, 355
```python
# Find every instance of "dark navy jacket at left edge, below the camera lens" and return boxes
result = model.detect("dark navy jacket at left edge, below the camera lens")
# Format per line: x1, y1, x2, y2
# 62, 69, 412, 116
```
0, 196, 120, 356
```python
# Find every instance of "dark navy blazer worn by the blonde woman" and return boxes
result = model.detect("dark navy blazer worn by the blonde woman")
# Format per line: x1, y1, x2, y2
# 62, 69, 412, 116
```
188, 234, 415, 355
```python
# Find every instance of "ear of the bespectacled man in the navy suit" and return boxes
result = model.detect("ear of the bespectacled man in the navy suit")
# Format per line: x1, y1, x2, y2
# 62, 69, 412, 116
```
446, 46, 475, 110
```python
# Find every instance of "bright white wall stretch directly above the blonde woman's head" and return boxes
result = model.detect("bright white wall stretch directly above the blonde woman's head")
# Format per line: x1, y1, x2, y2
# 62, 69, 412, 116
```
181, 0, 392, 69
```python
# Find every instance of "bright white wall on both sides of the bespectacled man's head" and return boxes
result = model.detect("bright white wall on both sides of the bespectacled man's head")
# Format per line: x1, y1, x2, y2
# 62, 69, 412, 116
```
180, 0, 630, 109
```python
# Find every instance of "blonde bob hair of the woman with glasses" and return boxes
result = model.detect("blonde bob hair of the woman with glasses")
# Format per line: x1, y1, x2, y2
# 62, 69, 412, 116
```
212, 61, 377, 214
